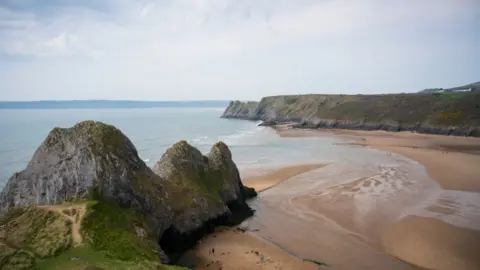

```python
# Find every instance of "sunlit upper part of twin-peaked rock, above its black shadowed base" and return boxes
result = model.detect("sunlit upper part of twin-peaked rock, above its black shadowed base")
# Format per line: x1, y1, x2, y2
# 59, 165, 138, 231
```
153, 141, 256, 233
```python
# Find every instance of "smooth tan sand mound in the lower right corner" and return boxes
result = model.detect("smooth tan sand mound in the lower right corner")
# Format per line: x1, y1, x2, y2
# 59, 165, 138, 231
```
384, 216, 480, 270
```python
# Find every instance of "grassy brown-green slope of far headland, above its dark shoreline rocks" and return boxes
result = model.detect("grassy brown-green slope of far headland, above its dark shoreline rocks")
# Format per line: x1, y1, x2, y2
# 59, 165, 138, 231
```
227, 92, 480, 126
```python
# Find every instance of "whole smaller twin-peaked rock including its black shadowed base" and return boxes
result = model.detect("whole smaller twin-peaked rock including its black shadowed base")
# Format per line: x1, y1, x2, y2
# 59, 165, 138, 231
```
153, 141, 256, 259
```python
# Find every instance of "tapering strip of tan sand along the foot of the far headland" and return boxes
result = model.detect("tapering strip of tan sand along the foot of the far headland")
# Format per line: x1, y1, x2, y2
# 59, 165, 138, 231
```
278, 126, 480, 192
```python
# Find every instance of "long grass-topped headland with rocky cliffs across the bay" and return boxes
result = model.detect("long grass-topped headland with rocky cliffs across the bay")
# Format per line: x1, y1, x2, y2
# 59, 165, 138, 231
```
222, 92, 480, 137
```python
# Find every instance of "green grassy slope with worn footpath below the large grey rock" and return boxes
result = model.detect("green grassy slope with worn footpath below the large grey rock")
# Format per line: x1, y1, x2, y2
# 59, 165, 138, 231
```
0, 201, 188, 269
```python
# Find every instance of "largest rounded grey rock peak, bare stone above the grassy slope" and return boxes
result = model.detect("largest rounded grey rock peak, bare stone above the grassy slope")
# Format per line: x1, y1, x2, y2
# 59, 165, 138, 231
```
0, 121, 172, 236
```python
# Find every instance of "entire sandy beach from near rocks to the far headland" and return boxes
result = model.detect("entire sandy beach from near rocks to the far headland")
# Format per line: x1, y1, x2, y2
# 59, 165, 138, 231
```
188, 127, 480, 270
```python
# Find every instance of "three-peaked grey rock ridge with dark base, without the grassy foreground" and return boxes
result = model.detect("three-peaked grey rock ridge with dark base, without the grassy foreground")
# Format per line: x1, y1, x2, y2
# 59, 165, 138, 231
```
0, 121, 253, 268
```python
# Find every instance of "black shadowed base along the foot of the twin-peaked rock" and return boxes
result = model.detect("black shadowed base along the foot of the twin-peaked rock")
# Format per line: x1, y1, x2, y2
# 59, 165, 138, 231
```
159, 201, 254, 264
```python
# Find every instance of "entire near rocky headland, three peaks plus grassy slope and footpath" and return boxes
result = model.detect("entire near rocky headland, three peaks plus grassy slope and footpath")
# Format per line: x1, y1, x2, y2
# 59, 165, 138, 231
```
0, 121, 256, 269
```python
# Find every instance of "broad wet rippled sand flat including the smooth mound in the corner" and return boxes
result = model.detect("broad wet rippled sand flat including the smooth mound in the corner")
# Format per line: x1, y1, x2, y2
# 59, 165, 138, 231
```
244, 138, 480, 269
